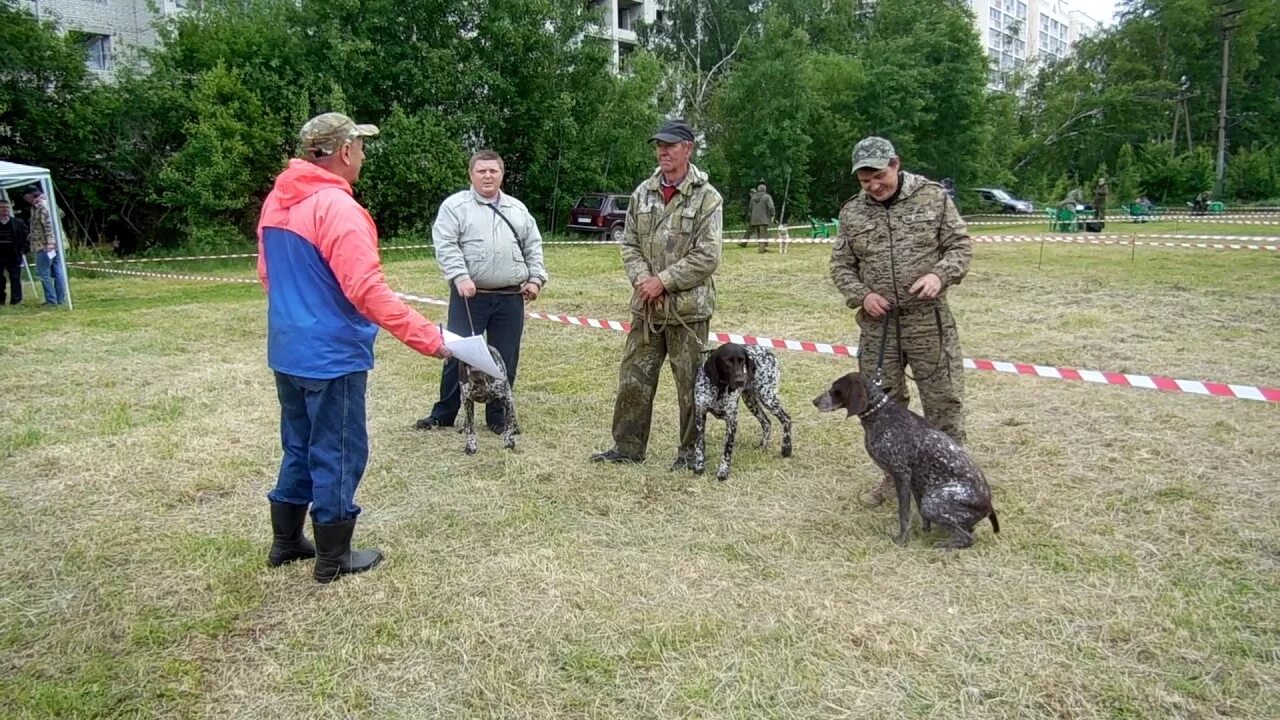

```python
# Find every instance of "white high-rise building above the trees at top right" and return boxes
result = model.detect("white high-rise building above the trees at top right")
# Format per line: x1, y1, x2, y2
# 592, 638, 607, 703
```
969, 0, 1101, 87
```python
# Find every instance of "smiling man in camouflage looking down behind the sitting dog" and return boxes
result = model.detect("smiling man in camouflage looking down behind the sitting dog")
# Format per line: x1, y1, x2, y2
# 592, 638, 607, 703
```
831, 137, 973, 505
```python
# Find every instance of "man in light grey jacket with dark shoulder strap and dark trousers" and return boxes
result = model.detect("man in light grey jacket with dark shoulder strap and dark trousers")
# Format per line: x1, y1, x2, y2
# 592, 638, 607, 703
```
415, 150, 547, 433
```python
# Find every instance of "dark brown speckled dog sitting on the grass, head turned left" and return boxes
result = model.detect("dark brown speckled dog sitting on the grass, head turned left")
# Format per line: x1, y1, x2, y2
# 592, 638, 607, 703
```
813, 373, 1000, 548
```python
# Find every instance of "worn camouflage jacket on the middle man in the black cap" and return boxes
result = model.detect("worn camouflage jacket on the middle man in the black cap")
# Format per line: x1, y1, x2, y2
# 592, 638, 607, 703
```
622, 164, 724, 320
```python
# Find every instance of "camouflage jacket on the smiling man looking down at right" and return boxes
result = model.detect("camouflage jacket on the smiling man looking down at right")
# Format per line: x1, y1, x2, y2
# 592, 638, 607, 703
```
831, 173, 973, 310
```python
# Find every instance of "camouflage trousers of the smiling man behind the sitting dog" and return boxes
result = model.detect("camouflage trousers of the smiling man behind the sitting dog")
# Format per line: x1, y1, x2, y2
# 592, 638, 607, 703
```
858, 304, 965, 445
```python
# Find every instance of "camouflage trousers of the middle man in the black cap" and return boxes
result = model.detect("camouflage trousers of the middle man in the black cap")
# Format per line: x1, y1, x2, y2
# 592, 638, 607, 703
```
613, 319, 710, 457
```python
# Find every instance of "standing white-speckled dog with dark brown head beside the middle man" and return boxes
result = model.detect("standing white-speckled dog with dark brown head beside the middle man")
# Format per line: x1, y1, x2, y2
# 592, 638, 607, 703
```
692, 342, 791, 480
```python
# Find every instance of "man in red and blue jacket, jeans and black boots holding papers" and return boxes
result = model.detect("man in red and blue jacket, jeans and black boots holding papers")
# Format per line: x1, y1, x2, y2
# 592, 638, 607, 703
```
257, 113, 449, 583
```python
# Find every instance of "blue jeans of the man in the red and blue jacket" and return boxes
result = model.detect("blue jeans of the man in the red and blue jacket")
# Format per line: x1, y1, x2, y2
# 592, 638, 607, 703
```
266, 372, 369, 524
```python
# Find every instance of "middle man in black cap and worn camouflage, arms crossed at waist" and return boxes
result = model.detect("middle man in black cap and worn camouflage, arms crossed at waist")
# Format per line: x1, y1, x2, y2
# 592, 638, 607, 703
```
591, 120, 723, 470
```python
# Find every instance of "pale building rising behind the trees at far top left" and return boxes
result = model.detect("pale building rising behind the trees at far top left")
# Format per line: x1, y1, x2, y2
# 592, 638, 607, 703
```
27, 0, 192, 76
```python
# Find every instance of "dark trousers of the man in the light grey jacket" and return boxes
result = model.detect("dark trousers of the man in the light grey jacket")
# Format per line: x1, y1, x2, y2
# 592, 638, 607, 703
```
431, 286, 525, 425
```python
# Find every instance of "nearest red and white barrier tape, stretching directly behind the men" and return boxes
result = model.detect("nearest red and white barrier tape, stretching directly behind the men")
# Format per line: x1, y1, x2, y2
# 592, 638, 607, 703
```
70, 263, 1280, 404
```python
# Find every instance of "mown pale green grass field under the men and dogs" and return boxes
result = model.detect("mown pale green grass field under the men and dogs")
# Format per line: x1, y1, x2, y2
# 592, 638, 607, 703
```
0, 234, 1280, 719
